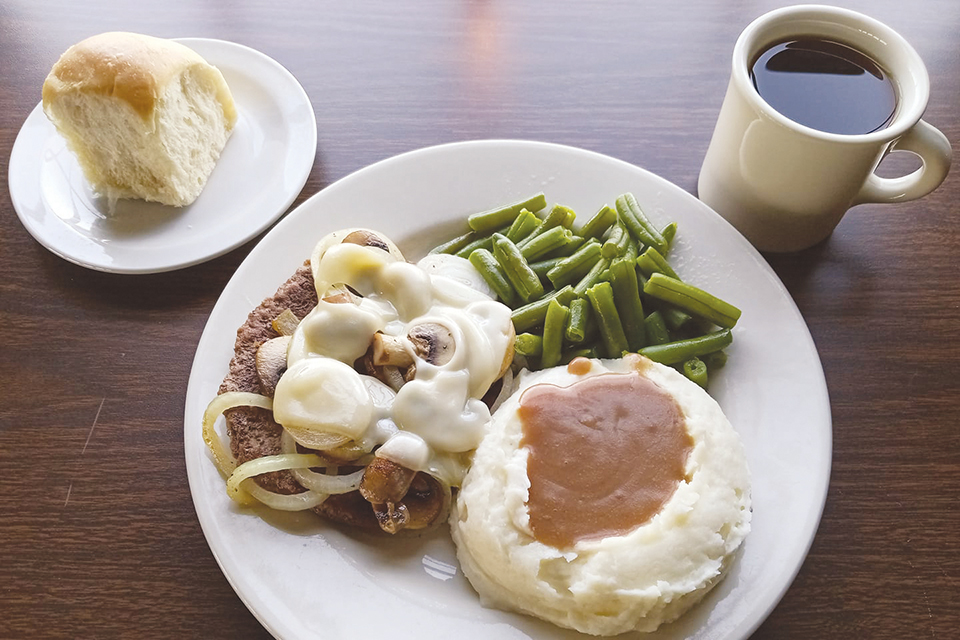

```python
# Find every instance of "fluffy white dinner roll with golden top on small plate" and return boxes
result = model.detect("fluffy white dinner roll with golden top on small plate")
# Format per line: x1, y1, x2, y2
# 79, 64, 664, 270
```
43, 32, 237, 207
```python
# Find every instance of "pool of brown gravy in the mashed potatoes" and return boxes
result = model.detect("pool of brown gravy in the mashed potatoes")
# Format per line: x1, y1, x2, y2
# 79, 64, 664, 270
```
519, 363, 693, 548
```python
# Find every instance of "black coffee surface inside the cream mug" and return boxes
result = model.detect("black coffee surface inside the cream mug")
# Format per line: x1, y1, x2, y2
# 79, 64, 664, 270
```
750, 38, 897, 134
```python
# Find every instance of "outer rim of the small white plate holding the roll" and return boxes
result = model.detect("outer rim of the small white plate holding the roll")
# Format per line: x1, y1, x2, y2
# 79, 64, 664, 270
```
7, 36, 318, 275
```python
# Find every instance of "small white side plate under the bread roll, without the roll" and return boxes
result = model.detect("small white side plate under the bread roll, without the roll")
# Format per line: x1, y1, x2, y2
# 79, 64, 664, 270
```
9, 38, 317, 273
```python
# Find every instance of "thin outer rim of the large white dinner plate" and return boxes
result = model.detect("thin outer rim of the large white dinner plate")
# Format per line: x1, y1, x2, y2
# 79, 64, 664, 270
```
184, 138, 833, 639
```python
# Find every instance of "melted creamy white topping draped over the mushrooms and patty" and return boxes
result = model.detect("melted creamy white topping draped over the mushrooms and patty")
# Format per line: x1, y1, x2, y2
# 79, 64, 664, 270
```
274, 243, 513, 485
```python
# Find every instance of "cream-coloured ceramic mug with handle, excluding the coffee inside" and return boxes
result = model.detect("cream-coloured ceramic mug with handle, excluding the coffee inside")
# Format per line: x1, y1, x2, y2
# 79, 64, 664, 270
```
698, 5, 952, 252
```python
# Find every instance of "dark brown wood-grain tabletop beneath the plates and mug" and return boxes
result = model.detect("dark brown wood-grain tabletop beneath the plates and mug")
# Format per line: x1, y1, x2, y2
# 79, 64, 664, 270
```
0, 0, 960, 640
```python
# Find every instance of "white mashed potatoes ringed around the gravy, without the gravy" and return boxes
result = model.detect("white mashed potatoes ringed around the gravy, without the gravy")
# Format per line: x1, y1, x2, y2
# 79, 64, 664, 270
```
451, 356, 750, 635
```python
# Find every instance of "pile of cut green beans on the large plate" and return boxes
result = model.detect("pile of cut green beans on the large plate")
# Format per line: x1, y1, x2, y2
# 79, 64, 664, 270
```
431, 193, 740, 387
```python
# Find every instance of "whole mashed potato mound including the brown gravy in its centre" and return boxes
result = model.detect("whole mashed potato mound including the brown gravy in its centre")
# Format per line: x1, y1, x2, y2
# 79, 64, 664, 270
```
450, 355, 751, 636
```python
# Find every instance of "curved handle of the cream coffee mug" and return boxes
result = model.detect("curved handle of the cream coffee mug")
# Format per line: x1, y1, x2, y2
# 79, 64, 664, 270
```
854, 120, 953, 204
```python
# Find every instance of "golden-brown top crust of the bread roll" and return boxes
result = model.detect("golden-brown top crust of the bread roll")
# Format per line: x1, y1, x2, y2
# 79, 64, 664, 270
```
43, 31, 237, 128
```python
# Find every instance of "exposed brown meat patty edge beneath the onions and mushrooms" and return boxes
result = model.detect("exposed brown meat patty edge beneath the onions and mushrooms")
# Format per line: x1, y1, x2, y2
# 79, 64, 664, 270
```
219, 261, 380, 531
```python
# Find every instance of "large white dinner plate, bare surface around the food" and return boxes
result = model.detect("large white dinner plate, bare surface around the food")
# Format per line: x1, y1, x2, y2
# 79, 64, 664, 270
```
184, 141, 831, 640
